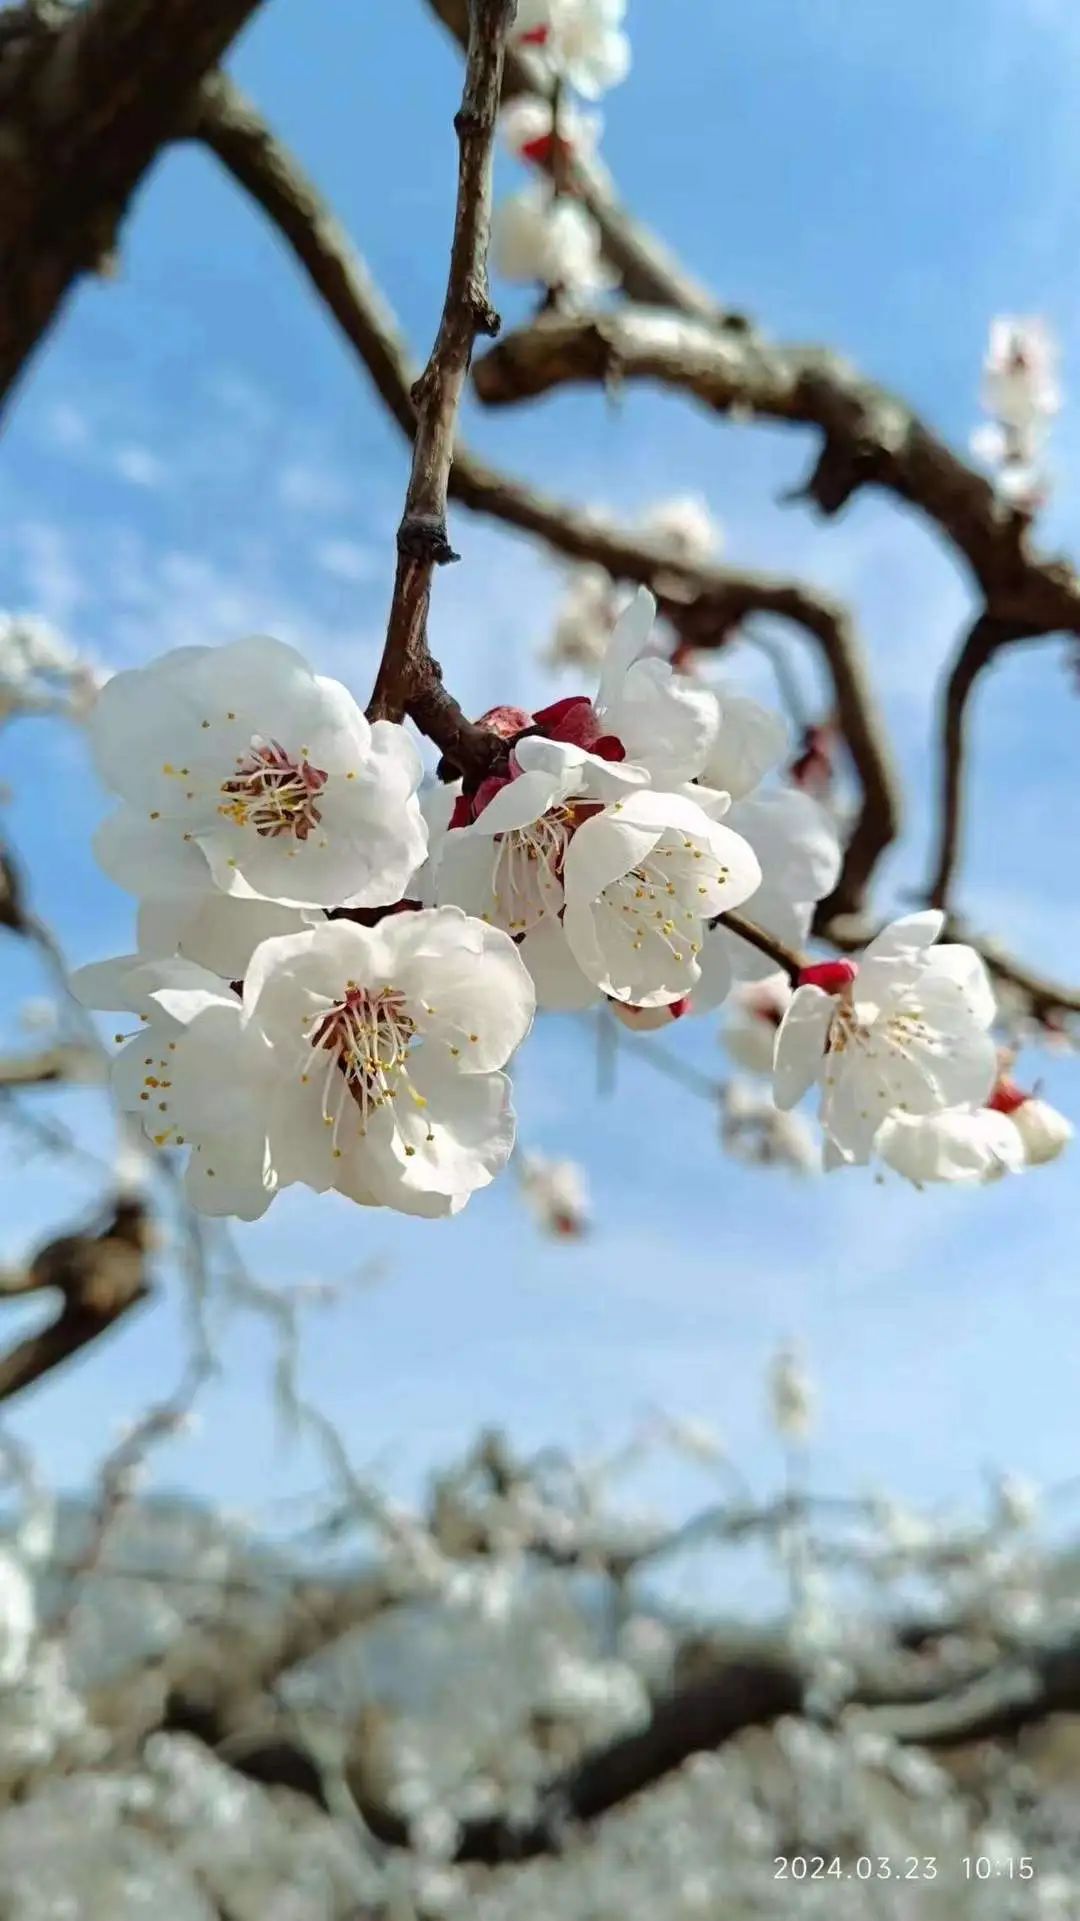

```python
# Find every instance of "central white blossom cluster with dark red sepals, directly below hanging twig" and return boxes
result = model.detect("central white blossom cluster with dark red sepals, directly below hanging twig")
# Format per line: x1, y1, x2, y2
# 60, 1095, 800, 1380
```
425, 590, 838, 1024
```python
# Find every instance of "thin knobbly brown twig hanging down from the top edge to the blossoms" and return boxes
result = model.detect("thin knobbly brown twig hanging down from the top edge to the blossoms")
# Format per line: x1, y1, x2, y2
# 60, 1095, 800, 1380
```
369, 0, 515, 720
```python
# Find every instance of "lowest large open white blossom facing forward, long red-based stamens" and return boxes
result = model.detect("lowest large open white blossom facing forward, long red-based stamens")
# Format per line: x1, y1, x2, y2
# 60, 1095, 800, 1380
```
239, 907, 534, 1214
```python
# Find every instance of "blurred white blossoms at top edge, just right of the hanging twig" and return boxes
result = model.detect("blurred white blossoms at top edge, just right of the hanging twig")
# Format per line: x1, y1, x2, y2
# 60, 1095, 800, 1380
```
492, 0, 630, 298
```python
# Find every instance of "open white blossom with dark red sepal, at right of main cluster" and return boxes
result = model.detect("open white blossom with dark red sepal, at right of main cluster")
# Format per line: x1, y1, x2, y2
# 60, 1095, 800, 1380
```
774, 912, 997, 1166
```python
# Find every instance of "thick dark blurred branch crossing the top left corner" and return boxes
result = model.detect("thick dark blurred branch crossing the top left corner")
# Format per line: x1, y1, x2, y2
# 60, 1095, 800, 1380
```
0, 0, 259, 416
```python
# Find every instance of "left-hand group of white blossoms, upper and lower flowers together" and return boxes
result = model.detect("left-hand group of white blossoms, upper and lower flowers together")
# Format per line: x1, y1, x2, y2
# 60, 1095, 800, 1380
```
75, 640, 534, 1220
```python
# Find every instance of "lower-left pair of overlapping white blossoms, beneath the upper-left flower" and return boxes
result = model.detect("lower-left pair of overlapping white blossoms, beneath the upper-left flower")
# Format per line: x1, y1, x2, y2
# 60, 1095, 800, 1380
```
75, 907, 534, 1220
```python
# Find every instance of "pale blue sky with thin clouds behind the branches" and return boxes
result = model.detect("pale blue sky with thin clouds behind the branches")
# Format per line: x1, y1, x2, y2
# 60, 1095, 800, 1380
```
0, 0, 1080, 1598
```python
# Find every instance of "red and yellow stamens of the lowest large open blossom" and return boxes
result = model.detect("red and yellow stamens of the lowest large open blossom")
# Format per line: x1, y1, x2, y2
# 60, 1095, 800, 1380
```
302, 980, 425, 1153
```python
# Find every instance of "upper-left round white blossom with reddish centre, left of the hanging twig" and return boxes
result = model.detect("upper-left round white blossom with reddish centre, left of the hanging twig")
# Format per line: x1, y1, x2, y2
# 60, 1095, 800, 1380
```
90, 638, 427, 907
